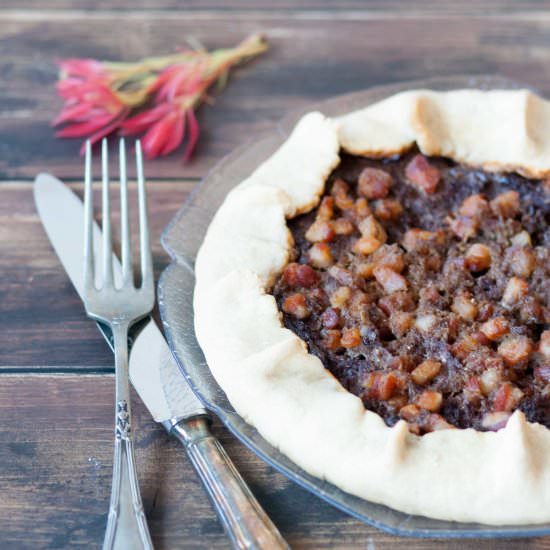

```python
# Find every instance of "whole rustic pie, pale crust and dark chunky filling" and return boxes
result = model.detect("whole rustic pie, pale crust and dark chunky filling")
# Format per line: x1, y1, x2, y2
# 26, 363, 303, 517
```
194, 90, 550, 525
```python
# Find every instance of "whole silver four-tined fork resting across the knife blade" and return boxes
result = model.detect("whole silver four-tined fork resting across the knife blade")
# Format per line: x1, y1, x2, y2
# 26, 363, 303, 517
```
84, 139, 155, 550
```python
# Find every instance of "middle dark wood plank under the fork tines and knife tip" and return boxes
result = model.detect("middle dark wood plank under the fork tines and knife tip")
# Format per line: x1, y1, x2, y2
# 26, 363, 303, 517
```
0, 182, 194, 370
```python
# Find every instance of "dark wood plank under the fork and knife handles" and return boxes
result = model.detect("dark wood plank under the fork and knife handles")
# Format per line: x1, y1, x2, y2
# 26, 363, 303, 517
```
0, 375, 550, 550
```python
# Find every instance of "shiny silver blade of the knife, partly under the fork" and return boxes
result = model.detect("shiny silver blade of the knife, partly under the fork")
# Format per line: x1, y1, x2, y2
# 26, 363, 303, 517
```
34, 174, 207, 429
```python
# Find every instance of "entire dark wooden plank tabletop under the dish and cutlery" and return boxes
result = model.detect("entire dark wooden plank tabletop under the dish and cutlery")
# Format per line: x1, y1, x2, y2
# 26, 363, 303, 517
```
0, 0, 550, 550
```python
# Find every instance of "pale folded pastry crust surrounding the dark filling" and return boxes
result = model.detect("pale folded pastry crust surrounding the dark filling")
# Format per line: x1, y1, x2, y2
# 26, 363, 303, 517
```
194, 90, 550, 524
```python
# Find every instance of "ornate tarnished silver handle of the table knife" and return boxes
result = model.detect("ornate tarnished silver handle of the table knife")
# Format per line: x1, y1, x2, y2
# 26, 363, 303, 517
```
170, 417, 290, 550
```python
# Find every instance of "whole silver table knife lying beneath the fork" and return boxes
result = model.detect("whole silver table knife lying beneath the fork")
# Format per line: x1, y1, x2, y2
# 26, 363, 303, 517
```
34, 174, 289, 549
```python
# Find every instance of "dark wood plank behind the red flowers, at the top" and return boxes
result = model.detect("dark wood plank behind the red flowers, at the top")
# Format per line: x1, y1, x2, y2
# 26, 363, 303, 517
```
0, 14, 550, 179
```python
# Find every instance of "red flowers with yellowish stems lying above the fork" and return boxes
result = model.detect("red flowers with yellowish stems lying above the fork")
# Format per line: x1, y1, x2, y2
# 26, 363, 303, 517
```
52, 35, 267, 161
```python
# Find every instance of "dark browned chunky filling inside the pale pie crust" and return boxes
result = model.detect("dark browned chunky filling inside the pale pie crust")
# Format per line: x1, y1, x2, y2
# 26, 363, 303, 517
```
273, 151, 550, 434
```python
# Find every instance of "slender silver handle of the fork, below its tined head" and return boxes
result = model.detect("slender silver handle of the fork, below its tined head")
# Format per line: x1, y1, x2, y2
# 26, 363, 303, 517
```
103, 323, 153, 550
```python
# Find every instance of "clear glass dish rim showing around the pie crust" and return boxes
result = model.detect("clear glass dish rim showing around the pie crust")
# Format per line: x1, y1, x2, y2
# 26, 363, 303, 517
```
159, 76, 550, 538
